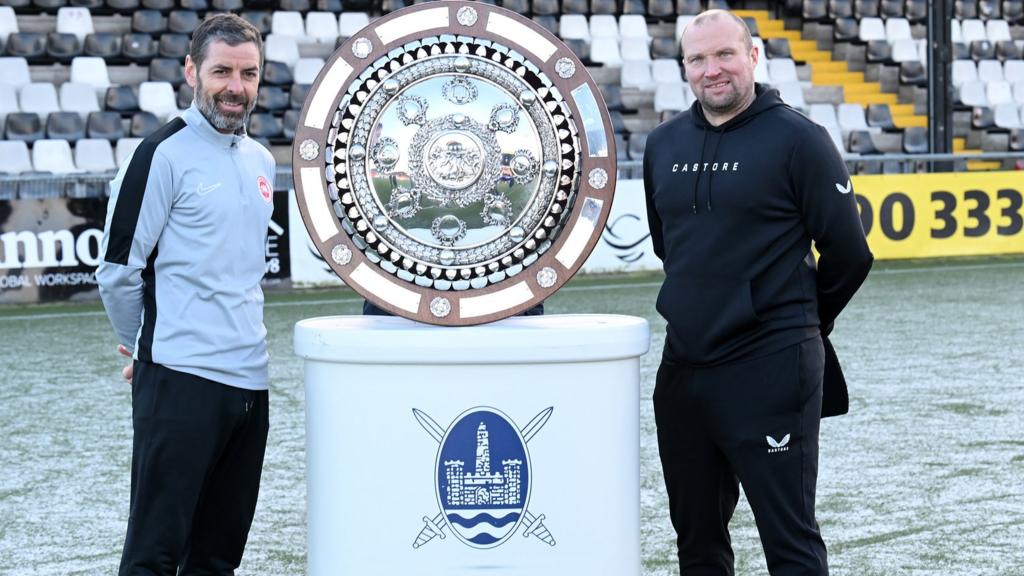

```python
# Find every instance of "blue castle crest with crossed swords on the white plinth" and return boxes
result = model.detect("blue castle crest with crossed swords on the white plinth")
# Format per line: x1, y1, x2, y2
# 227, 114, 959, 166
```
413, 406, 555, 548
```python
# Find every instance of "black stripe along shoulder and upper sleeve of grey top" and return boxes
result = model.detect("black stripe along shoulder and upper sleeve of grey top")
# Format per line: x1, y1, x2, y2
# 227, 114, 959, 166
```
103, 118, 186, 265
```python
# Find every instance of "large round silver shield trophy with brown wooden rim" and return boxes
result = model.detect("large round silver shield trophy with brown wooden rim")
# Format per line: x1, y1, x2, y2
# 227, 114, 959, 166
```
292, 0, 615, 326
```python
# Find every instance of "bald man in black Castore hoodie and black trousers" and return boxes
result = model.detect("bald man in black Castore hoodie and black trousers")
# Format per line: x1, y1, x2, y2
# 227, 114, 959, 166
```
644, 10, 872, 576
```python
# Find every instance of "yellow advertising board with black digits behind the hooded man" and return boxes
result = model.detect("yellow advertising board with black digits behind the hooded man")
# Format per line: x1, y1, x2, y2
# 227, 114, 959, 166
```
852, 172, 1024, 259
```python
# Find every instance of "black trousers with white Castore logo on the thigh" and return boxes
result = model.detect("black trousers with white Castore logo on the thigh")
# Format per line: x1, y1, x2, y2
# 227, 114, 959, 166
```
654, 338, 828, 576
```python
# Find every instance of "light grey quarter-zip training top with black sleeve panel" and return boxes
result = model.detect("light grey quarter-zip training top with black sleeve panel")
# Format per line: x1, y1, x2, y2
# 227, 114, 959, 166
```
96, 106, 274, 389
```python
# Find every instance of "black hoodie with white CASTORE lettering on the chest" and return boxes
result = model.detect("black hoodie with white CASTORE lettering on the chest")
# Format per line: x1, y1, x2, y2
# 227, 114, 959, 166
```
643, 84, 872, 366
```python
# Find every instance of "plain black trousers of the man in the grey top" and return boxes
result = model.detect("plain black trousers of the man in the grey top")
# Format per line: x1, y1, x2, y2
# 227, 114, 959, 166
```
119, 361, 268, 576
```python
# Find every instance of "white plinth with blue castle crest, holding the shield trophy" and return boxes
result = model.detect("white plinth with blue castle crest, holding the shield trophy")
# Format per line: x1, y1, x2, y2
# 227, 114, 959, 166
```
295, 315, 649, 576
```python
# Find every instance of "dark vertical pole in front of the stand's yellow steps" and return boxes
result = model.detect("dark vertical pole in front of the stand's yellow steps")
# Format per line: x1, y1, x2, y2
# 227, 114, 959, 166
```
928, 0, 953, 171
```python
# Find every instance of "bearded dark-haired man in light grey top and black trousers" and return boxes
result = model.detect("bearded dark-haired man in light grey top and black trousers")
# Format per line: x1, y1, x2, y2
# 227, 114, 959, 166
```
96, 14, 274, 576
